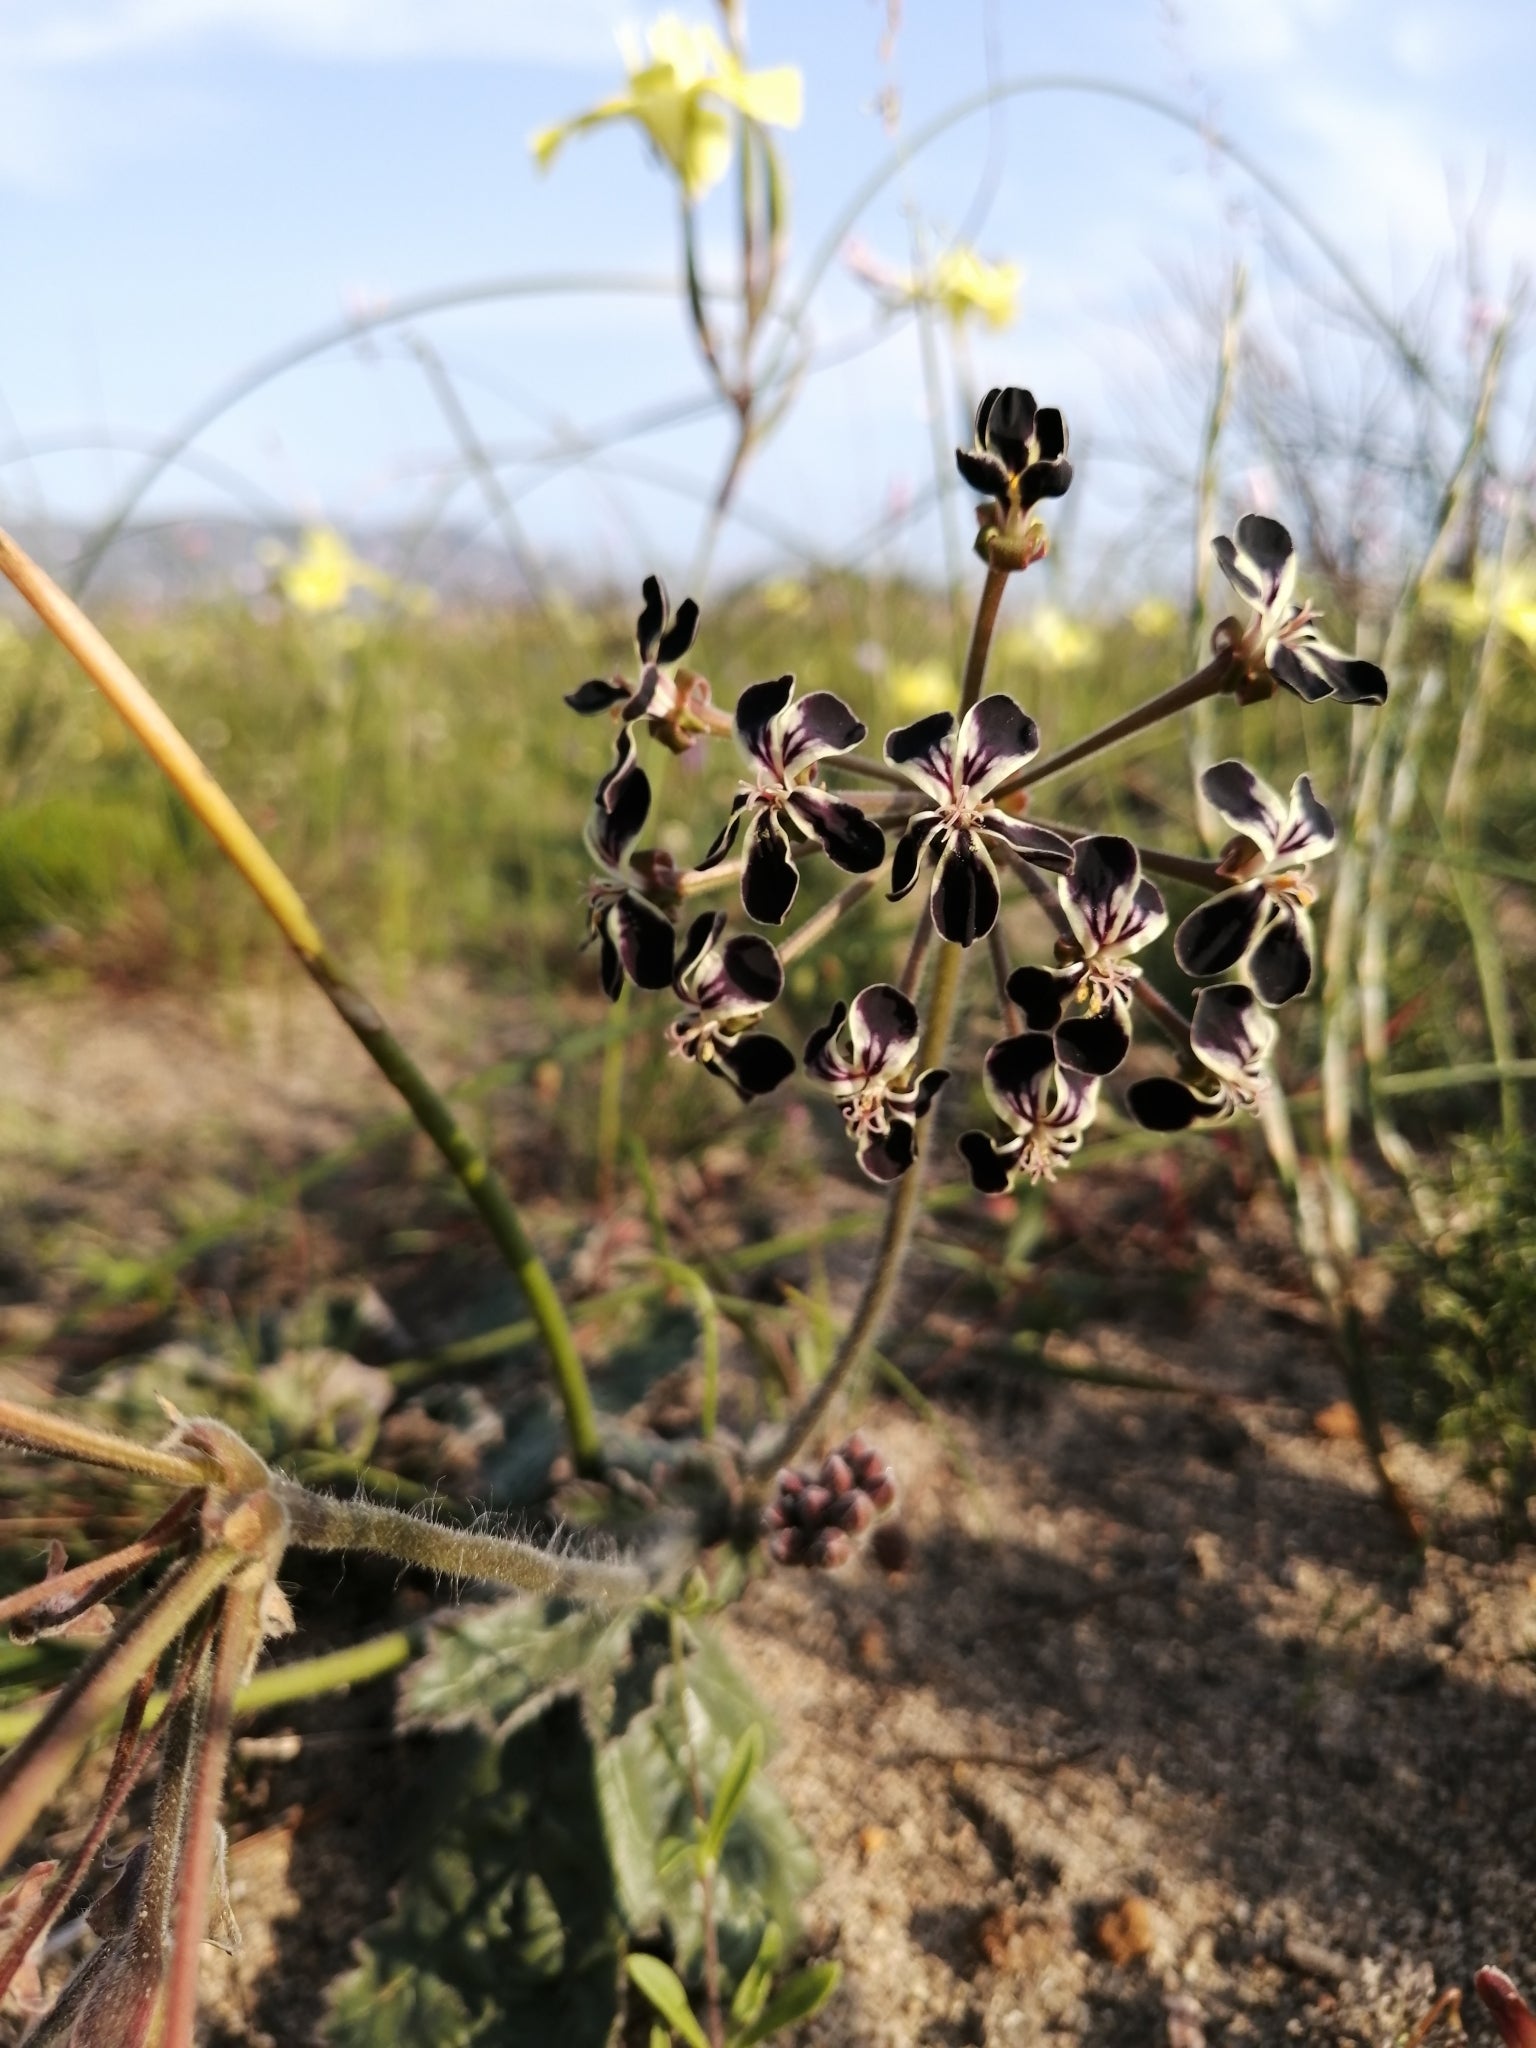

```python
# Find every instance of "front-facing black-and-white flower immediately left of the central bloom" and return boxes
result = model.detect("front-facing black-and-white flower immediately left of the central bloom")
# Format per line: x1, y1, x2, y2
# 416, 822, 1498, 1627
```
698, 676, 885, 924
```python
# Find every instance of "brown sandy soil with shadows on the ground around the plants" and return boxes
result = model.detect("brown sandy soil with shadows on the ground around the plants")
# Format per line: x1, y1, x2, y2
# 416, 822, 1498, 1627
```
0, 991, 1536, 2048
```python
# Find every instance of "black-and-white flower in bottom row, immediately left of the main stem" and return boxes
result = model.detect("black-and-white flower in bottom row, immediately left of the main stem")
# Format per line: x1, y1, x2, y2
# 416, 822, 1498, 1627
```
805, 981, 948, 1180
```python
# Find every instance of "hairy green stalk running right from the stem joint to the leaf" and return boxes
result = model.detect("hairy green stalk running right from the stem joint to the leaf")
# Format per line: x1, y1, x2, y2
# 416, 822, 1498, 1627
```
272, 1477, 649, 1606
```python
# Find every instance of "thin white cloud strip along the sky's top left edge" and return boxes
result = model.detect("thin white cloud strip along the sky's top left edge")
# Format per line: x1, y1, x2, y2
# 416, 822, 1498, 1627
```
0, 0, 629, 70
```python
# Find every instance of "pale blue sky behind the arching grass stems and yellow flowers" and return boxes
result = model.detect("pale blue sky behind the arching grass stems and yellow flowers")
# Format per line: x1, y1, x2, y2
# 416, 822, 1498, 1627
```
0, 0, 1536, 598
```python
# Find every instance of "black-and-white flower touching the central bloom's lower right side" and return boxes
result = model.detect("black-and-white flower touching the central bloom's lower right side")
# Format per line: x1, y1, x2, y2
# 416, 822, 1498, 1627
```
1008, 831, 1167, 1075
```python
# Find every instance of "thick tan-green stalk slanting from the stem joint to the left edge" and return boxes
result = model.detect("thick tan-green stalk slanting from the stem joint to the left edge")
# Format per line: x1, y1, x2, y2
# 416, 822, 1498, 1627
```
0, 1548, 246, 1864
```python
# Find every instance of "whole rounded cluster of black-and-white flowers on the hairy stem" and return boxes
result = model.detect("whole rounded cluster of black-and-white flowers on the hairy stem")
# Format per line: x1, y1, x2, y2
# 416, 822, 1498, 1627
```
567, 389, 1386, 1187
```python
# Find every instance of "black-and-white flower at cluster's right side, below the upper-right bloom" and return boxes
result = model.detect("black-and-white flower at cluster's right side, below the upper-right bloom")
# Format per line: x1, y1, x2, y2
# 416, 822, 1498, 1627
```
1174, 762, 1335, 1010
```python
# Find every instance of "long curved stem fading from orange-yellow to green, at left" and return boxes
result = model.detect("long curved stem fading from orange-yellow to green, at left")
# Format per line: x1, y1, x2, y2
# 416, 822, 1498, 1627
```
0, 532, 602, 1485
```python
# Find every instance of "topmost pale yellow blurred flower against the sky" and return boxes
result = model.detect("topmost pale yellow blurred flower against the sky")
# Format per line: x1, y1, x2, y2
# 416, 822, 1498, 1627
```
528, 14, 803, 199
